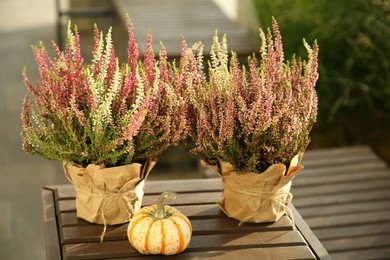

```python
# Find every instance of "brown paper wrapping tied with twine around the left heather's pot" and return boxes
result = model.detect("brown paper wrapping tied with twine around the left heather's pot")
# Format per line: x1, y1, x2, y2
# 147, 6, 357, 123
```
63, 159, 157, 225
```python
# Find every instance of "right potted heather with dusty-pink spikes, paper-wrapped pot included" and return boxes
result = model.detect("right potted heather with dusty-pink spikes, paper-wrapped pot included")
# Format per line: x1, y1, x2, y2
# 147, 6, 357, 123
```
186, 20, 318, 222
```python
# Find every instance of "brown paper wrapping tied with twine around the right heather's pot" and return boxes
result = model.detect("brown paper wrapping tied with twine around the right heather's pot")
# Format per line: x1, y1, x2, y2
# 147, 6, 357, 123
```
202, 154, 303, 223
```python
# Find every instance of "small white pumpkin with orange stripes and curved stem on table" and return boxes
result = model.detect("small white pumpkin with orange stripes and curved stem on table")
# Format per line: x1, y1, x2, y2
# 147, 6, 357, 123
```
127, 191, 192, 255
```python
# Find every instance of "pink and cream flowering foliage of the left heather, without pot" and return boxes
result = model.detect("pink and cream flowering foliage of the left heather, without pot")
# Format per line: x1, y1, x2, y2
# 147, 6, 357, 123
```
21, 20, 187, 166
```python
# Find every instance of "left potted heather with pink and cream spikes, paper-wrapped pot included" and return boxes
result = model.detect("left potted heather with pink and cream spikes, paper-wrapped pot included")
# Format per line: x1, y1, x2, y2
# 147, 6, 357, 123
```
21, 20, 187, 225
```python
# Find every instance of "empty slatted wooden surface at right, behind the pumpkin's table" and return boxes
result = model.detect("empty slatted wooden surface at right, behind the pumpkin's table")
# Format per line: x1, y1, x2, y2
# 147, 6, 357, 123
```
291, 146, 390, 260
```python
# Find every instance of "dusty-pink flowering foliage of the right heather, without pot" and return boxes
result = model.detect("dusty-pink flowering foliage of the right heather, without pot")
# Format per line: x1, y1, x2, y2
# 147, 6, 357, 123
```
187, 20, 318, 172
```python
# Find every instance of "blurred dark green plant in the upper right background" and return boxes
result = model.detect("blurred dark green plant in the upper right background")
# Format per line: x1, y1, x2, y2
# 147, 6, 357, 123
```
253, 0, 390, 160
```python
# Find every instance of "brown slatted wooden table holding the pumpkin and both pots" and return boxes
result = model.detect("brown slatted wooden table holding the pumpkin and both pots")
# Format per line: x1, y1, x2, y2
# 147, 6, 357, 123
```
42, 178, 330, 259
